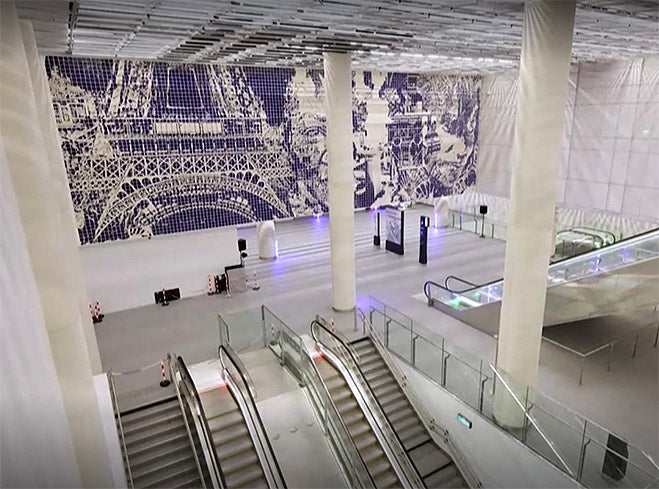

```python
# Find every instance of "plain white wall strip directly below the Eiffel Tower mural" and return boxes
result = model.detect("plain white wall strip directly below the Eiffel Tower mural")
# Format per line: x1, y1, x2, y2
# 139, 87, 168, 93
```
80, 227, 238, 313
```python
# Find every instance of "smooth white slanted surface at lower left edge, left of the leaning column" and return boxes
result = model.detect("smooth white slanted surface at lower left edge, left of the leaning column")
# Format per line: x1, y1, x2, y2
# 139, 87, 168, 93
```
0, 142, 81, 487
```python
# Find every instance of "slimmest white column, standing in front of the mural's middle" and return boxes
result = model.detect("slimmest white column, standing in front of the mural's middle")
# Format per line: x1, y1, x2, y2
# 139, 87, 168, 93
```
324, 53, 356, 311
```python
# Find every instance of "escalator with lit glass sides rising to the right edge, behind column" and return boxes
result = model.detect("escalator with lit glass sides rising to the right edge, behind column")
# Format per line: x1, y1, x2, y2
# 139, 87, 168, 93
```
423, 229, 659, 335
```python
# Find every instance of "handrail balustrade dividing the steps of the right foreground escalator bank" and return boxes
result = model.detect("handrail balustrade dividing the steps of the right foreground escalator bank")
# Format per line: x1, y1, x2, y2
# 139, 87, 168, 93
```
311, 316, 423, 487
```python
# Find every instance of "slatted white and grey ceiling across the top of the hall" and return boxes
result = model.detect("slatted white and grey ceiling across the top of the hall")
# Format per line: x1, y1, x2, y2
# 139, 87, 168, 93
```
16, 0, 659, 73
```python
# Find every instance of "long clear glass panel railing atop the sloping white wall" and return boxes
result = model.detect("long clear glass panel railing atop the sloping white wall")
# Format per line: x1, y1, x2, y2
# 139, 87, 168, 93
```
365, 298, 659, 488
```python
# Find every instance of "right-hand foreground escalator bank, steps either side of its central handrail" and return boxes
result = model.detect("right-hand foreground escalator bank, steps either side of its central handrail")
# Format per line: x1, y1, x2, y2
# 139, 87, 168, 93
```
311, 320, 469, 488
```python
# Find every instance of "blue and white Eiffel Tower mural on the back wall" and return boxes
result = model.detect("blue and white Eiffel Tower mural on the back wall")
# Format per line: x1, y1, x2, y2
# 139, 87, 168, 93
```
46, 57, 480, 244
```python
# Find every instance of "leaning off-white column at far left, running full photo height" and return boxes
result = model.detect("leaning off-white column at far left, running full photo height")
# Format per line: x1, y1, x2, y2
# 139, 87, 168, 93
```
0, 2, 112, 487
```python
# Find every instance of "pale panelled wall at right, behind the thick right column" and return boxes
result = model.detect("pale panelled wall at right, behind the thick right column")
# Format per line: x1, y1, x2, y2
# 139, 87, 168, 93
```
477, 56, 659, 220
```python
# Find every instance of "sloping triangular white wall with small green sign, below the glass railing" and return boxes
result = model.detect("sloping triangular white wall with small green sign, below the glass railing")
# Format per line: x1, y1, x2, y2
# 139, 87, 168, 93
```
398, 360, 581, 488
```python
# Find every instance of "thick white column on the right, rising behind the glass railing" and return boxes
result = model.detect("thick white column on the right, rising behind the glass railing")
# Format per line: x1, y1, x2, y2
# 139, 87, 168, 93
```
495, 0, 575, 426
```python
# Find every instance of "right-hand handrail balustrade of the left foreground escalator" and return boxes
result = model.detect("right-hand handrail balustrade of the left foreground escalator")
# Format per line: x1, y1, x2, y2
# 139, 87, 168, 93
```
217, 345, 286, 489
